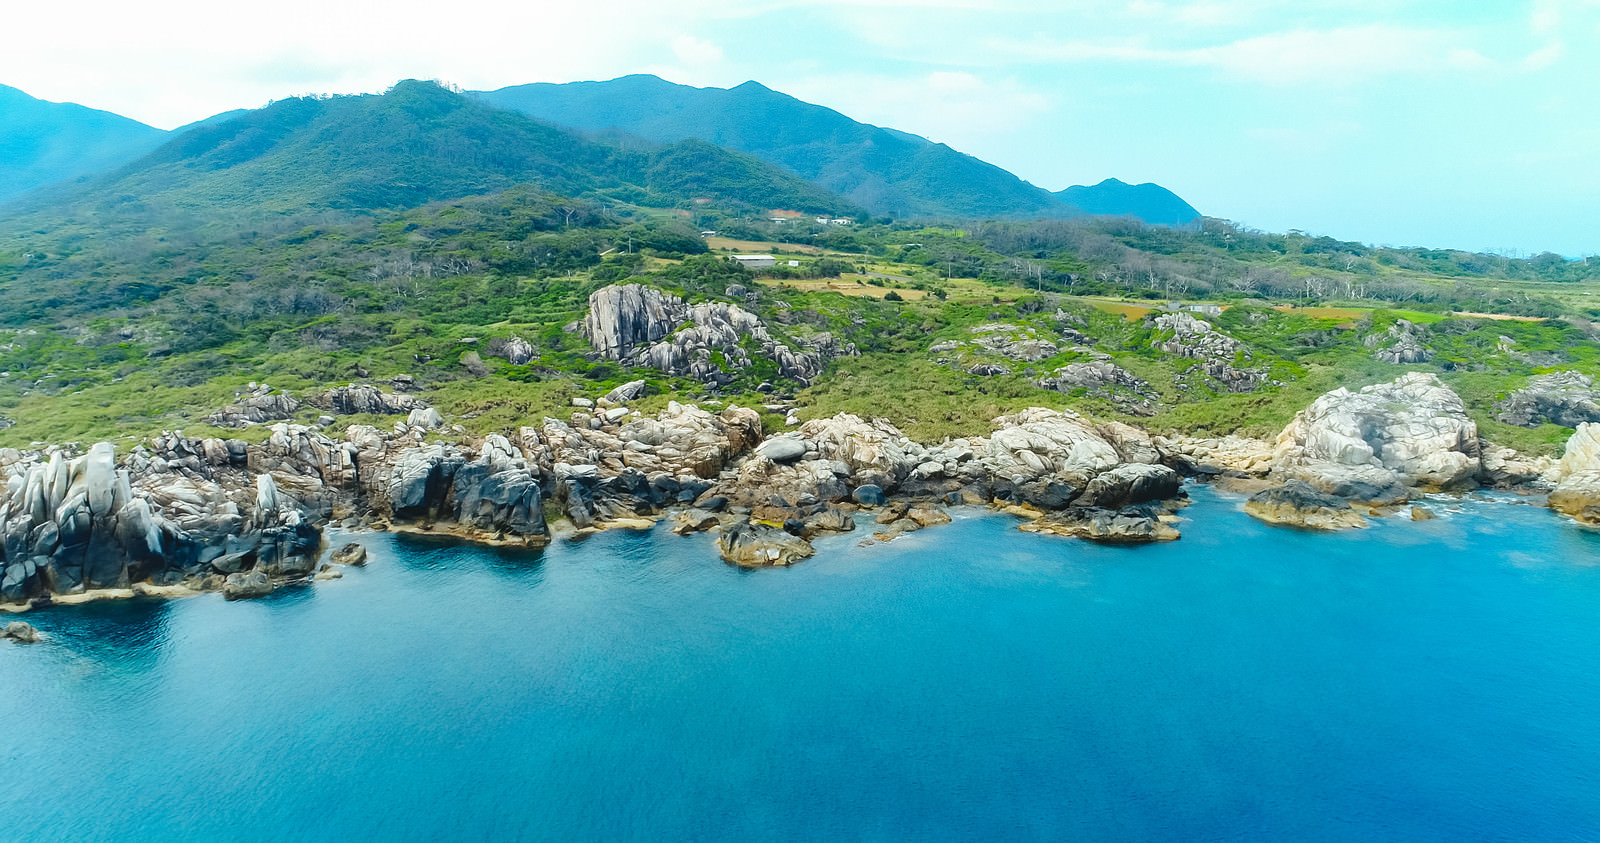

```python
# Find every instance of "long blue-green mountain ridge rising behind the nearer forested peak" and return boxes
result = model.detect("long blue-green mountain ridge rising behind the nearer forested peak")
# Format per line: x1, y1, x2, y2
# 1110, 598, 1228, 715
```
477, 75, 1075, 218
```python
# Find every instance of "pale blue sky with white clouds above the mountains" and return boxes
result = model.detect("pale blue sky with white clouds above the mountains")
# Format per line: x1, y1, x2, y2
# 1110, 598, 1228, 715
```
0, 0, 1600, 256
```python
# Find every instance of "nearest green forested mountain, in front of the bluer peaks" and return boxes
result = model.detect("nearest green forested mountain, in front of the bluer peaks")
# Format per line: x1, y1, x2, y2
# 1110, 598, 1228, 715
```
18, 80, 854, 213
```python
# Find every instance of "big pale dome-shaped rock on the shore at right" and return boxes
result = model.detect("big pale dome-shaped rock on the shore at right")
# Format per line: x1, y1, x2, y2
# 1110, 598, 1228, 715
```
1272, 373, 1482, 501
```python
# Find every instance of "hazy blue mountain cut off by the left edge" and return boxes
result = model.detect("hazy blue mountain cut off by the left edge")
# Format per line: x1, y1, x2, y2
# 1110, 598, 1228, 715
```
0, 85, 166, 202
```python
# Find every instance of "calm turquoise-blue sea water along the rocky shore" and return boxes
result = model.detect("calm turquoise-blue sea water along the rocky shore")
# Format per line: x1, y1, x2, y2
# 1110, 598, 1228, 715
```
0, 489, 1600, 841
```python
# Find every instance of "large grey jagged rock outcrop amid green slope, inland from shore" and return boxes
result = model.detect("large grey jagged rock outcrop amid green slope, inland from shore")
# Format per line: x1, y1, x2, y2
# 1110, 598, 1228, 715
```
582, 285, 856, 384
